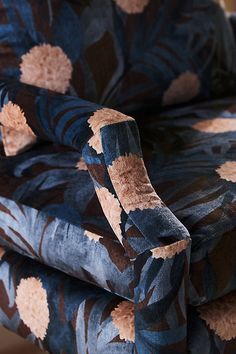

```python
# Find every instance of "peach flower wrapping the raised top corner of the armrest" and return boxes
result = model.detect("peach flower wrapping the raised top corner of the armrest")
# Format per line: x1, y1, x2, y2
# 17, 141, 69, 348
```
88, 108, 134, 154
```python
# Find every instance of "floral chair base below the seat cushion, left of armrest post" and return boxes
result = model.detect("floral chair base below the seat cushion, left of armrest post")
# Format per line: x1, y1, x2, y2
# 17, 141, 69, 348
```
0, 251, 135, 354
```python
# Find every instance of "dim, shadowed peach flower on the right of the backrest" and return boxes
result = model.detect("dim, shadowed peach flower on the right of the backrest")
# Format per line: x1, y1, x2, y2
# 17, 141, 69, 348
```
163, 71, 201, 106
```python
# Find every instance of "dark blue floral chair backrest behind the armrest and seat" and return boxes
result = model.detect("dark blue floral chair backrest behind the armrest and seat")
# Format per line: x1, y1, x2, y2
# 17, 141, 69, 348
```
0, 0, 236, 114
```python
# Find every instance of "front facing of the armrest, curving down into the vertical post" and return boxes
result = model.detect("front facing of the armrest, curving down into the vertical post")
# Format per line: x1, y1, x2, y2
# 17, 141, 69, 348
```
83, 111, 191, 354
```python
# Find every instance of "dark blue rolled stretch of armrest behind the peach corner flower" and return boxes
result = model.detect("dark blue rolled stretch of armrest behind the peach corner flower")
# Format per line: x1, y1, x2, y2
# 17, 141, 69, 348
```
0, 77, 100, 150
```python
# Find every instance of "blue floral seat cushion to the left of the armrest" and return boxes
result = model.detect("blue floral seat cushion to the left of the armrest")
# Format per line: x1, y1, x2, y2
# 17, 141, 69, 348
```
0, 142, 133, 299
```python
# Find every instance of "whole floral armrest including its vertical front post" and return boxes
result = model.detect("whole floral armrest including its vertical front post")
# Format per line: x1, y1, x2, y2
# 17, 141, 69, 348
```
0, 78, 191, 354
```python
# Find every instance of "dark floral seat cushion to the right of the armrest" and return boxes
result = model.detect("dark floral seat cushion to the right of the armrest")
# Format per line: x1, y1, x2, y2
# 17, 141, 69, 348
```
140, 97, 236, 305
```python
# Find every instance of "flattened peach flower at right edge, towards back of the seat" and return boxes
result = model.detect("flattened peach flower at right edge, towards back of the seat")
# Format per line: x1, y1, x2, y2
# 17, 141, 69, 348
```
193, 118, 236, 134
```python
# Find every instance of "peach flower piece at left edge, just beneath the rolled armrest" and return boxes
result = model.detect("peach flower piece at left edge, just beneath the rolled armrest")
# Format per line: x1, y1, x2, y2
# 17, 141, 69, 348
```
1, 127, 37, 156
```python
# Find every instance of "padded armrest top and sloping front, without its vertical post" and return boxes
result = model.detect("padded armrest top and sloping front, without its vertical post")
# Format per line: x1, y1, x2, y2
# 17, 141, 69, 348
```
0, 77, 189, 250
